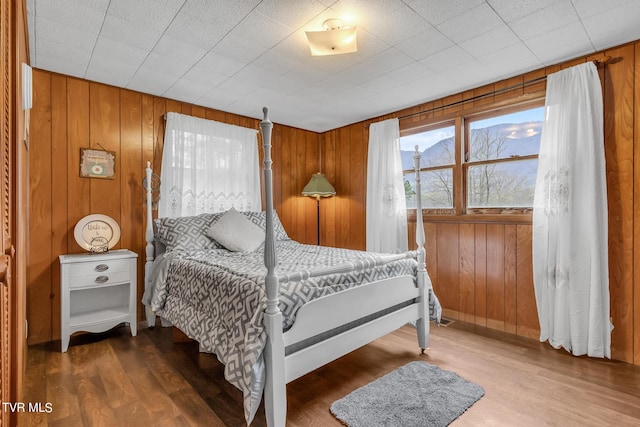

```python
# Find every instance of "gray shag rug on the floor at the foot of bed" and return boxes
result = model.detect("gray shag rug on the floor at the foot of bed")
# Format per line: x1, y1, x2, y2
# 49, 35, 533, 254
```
330, 361, 484, 427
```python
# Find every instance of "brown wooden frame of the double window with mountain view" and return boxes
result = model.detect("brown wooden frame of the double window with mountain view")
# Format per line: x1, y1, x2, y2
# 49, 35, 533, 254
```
400, 94, 544, 224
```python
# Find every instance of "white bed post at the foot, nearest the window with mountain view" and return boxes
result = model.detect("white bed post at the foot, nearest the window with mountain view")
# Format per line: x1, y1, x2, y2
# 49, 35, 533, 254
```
413, 145, 431, 353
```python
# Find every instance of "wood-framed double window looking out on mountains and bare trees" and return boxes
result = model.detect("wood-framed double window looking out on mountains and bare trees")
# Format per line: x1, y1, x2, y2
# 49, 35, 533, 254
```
400, 102, 544, 215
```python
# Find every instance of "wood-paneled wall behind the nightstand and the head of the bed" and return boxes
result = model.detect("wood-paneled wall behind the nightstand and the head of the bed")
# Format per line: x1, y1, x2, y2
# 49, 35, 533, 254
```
27, 70, 320, 344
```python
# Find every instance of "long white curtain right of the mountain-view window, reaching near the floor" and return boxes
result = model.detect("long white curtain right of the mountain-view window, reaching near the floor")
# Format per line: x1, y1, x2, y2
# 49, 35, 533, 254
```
533, 62, 612, 358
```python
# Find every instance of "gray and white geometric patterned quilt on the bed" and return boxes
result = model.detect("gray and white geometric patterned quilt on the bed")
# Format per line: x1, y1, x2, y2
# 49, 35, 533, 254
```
143, 240, 440, 423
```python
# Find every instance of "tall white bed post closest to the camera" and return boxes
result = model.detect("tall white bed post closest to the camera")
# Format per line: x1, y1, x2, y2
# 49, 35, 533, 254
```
260, 107, 287, 427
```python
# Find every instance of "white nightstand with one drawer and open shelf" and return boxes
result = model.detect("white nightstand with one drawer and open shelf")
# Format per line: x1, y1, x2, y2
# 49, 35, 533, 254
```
60, 249, 138, 352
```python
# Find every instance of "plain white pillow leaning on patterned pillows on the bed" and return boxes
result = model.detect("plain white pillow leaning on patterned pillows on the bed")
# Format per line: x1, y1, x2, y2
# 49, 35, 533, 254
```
207, 208, 264, 252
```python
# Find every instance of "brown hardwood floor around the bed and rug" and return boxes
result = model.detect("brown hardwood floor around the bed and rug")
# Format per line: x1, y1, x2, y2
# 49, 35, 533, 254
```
20, 322, 640, 427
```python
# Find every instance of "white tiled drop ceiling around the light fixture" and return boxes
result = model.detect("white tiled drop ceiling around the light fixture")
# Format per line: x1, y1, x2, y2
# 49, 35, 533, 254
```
27, 0, 640, 132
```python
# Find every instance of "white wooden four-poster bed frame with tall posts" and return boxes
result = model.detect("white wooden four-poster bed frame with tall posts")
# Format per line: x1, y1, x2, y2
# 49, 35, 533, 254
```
145, 107, 431, 426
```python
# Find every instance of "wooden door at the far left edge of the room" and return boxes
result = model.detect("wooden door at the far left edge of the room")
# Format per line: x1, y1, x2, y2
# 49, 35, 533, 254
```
0, 0, 28, 427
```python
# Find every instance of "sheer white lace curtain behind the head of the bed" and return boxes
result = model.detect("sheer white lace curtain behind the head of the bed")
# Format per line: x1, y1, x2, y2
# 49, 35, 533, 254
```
158, 113, 262, 217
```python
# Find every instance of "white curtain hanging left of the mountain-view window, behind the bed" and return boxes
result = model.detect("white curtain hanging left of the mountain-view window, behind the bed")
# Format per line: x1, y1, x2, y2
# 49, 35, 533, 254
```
367, 119, 408, 253
